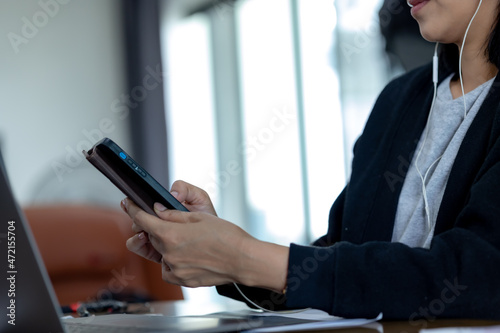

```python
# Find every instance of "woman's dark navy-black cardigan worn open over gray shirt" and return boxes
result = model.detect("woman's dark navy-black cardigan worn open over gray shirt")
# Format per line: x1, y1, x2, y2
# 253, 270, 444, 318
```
218, 62, 500, 322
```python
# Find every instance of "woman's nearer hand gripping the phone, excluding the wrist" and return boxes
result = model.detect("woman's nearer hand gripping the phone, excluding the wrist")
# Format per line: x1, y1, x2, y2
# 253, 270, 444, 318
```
124, 199, 252, 287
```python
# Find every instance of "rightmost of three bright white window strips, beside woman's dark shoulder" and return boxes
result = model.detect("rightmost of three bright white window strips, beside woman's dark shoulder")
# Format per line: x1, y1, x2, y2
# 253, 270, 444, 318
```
298, 0, 346, 239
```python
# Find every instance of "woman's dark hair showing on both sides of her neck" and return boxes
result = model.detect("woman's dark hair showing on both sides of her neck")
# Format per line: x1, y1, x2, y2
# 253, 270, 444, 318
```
441, 4, 500, 73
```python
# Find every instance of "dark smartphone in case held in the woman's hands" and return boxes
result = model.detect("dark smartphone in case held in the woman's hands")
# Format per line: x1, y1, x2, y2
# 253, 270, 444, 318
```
83, 138, 188, 215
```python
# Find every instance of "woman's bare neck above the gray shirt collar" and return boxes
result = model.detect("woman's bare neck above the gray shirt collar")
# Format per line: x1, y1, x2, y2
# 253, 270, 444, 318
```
450, 45, 498, 98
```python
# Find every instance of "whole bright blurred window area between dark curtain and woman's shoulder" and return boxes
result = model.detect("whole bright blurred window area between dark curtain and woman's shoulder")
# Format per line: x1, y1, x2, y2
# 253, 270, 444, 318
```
163, 0, 388, 298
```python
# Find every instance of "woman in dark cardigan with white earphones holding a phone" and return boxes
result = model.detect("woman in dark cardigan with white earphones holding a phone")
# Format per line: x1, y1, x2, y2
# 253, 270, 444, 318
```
122, 0, 500, 321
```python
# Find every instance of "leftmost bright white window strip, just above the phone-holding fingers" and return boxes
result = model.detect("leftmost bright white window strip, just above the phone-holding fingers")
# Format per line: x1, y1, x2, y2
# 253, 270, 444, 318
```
166, 14, 217, 206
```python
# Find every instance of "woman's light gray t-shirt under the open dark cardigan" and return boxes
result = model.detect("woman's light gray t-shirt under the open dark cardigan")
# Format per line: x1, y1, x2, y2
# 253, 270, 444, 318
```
392, 76, 494, 248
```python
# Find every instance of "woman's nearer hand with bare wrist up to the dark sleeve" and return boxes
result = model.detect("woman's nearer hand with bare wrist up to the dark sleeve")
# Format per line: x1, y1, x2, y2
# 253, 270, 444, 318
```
124, 196, 288, 291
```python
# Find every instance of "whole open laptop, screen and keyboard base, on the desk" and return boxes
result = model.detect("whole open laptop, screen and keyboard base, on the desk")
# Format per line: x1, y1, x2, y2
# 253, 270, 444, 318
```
0, 151, 277, 333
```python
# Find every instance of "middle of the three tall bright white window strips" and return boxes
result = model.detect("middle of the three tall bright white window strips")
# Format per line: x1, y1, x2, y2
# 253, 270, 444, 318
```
237, 0, 305, 245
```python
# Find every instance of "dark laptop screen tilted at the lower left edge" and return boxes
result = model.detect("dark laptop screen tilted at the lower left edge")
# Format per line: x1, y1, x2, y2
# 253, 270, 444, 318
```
0, 152, 64, 332
